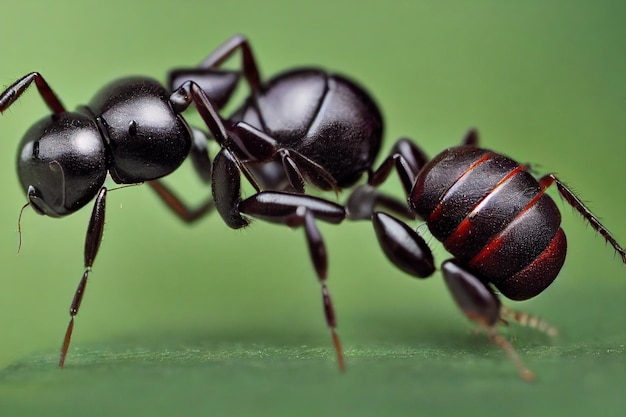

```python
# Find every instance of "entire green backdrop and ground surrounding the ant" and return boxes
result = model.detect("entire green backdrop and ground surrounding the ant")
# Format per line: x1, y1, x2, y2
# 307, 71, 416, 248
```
0, 0, 626, 416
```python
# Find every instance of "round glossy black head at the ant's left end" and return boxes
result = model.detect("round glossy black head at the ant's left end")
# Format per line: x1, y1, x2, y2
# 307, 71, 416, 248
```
17, 112, 107, 217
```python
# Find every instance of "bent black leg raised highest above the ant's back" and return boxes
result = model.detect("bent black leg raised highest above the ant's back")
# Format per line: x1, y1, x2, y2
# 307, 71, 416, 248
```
168, 35, 261, 108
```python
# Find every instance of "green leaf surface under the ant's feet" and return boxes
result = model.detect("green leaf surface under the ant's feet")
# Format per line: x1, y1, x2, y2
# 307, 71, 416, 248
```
0, 332, 626, 416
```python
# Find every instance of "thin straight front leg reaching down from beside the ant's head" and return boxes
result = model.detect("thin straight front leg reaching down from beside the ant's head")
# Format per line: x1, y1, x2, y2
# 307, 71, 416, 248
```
59, 187, 107, 368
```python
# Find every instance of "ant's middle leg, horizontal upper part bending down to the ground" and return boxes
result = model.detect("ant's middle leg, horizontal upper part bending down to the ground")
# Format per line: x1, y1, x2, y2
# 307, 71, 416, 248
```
239, 191, 346, 371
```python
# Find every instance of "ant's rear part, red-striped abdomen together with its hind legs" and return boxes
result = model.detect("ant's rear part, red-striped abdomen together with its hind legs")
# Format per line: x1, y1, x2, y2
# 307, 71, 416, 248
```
369, 131, 626, 379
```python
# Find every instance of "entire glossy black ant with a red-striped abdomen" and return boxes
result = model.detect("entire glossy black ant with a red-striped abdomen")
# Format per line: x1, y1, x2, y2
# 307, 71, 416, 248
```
0, 36, 626, 379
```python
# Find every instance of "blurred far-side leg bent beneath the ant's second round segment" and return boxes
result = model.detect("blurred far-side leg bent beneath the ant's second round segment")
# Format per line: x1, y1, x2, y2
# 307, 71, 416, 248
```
148, 129, 215, 223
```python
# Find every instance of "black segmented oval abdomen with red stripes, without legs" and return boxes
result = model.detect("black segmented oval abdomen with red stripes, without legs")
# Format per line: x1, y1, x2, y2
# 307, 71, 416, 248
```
409, 146, 567, 300
